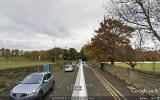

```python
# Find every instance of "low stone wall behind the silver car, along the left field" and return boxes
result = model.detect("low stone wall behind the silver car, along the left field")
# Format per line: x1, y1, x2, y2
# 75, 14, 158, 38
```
0, 63, 67, 94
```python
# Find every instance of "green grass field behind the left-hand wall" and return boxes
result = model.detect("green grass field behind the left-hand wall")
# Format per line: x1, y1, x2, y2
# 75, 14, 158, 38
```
0, 61, 52, 69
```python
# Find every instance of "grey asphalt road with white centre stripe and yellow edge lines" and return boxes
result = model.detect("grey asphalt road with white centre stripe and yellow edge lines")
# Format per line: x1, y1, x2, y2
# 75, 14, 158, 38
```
0, 64, 148, 100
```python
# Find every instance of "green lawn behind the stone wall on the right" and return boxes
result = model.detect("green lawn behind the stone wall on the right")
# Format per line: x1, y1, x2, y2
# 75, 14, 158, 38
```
115, 63, 160, 72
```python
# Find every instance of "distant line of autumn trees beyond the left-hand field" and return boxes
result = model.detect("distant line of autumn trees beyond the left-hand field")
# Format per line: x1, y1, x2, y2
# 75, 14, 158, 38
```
0, 47, 87, 62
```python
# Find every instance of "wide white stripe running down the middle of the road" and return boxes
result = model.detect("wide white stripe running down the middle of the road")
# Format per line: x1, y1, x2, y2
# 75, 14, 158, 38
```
71, 62, 88, 100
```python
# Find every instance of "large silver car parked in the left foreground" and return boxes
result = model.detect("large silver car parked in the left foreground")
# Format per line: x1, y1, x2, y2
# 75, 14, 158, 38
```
10, 72, 55, 100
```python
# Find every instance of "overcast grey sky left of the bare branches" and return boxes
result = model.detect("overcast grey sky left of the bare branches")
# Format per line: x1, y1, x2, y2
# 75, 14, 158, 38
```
0, 0, 104, 50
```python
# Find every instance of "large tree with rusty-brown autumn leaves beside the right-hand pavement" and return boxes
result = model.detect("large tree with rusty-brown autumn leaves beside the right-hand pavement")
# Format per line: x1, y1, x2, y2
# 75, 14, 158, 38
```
91, 18, 134, 64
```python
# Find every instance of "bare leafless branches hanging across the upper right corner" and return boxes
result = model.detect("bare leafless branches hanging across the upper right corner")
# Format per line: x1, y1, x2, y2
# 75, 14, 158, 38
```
105, 0, 160, 41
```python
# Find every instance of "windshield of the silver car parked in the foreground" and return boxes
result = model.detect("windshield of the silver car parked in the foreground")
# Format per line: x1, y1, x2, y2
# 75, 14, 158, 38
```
21, 74, 43, 84
